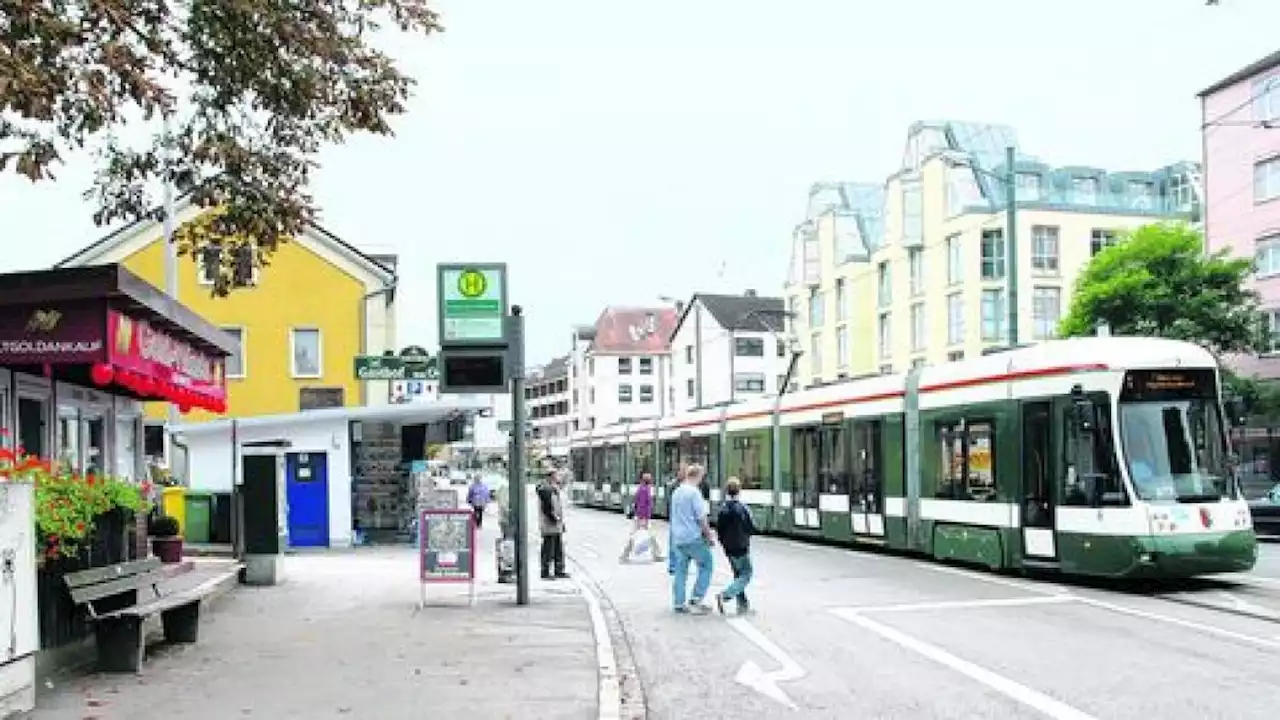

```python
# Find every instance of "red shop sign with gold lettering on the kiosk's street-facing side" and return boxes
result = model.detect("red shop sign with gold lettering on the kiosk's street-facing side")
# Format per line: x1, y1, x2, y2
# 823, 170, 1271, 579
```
106, 310, 227, 400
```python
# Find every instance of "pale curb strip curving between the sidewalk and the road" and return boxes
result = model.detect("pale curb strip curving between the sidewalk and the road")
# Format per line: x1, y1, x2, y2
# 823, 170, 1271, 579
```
564, 552, 649, 720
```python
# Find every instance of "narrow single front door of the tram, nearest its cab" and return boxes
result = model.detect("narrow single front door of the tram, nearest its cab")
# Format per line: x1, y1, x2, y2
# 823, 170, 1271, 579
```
1021, 402, 1057, 560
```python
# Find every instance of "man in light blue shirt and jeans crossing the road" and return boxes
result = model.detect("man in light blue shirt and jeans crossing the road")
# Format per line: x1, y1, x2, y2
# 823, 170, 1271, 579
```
669, 465, 716, 614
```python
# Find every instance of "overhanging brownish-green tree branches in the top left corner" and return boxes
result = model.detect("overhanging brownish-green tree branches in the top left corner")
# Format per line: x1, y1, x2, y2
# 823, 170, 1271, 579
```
0, 0, 440, 293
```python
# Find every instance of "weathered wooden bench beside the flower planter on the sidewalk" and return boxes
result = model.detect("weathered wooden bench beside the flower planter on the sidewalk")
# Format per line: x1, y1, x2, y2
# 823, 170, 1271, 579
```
63, 557, 212, 673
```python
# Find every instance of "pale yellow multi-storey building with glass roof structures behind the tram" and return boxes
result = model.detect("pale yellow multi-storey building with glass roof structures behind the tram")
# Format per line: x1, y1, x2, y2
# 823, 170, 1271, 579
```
786, 122, 1199, 387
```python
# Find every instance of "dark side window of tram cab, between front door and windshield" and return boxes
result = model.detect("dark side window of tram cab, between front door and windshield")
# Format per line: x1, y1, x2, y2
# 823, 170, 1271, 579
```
1061, 401, 1129, 507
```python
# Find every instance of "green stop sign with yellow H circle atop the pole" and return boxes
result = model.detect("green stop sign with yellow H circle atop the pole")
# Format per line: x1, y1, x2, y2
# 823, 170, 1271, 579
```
436, 263, 507, 346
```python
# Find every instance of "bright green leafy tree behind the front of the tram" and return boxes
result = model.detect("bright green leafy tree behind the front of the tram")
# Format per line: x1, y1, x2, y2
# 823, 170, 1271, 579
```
1059, 223, 1268, 354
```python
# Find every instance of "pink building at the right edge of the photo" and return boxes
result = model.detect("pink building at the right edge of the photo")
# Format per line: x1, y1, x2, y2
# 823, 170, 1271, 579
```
1199, 53, 1280, 378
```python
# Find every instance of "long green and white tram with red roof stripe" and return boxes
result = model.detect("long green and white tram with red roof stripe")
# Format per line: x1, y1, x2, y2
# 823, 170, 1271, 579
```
571, 337, 1257, 578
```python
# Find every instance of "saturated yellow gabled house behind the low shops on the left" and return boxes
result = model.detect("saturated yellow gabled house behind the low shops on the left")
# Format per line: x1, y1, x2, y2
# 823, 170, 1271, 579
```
58, 197, 396, 423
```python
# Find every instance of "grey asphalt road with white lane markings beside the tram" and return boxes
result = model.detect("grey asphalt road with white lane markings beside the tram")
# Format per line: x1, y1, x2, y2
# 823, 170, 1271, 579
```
566, 509, 1280, 720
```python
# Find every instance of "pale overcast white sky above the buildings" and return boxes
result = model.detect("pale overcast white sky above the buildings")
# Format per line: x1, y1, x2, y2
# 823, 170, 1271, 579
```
0, 0, 1280, 363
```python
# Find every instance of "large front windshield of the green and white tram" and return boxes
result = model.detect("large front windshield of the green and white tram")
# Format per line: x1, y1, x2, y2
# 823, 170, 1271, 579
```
1120, 370, 1238, 502
